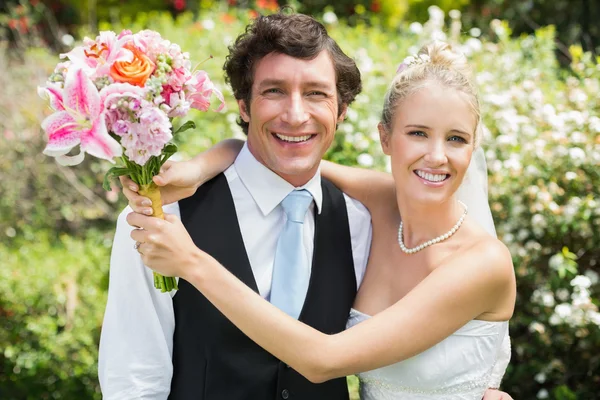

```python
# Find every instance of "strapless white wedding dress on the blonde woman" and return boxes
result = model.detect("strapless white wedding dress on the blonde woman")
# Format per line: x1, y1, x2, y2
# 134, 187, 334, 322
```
347, 309, 510, 400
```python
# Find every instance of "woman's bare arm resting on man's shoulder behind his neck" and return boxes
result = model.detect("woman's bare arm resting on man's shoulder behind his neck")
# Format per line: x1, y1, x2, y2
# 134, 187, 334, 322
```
321, 161, 397, 214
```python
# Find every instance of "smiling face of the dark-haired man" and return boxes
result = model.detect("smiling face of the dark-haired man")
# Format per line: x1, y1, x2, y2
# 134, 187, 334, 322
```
238, 51, 345, 186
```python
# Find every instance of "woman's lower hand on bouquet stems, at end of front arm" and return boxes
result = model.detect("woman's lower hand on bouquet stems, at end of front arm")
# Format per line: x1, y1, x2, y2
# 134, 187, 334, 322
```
127, 213, 202, 277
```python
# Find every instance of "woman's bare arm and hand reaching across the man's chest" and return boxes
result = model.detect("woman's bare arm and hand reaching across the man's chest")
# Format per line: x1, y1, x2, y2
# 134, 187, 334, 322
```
127, 213, 516, 382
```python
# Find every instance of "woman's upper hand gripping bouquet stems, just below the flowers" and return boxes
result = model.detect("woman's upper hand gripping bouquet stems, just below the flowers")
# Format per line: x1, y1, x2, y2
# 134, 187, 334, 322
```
119, 160, 203, 215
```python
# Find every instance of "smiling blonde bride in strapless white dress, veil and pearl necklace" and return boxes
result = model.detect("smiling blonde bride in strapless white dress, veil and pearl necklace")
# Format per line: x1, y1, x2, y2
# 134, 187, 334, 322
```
125, 42, 516, 400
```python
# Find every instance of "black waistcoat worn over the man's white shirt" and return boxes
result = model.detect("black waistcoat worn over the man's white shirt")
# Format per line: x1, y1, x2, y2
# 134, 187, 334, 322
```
169, 174, 356, 400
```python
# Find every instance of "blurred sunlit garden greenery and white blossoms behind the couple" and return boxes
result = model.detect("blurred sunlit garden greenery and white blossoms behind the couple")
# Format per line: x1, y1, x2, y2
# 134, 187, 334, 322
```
0, 0, 600, 400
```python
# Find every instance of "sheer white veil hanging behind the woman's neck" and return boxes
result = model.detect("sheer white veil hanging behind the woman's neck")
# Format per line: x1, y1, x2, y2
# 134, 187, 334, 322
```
456, 146, 497, 237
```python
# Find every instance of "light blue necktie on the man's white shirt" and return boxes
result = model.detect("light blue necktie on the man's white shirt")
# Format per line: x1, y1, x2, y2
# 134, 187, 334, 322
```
270, 190, 313, 318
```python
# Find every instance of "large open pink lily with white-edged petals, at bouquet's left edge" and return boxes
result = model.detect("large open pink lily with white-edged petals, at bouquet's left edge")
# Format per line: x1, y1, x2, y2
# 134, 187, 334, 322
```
42, 69, 123, 165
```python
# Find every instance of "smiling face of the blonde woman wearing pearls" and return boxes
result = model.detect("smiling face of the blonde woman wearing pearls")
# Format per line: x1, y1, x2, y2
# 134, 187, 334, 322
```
379, 83, 477, 209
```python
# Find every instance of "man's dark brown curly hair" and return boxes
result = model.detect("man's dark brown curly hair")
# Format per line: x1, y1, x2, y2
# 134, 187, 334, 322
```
223, 11, 362, 135
